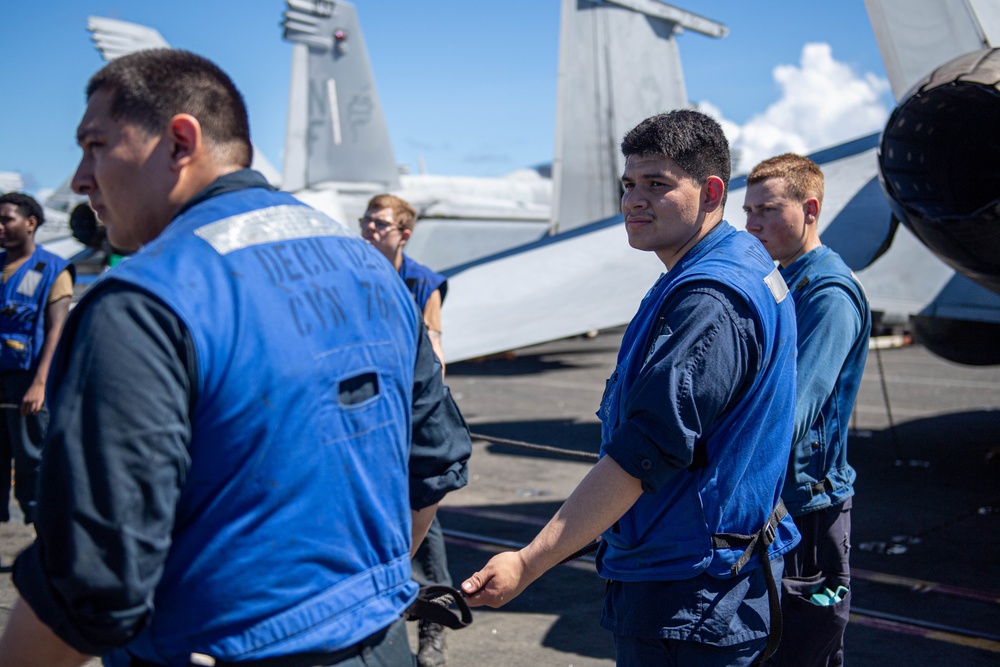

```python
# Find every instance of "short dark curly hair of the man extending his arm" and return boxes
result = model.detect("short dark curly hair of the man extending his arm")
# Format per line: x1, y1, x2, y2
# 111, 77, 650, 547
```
622, 109, 730, 203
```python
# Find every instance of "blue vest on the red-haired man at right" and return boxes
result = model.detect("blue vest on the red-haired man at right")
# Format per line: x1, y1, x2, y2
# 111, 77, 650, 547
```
781, 246, 872, 516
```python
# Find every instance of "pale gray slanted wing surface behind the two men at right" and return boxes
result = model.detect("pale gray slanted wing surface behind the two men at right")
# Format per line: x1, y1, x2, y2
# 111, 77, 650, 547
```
443, 136, 888, 362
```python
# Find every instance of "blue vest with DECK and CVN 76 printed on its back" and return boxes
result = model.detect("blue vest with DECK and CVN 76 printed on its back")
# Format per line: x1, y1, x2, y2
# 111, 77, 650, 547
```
105, 188, 420, 666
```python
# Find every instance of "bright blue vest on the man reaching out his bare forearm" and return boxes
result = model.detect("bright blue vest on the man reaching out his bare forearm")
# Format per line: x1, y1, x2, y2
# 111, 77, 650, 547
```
598, 222, 799, 581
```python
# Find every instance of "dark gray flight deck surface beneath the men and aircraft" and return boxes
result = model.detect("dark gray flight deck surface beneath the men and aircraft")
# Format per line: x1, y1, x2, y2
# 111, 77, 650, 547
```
0, 329, 1000, 667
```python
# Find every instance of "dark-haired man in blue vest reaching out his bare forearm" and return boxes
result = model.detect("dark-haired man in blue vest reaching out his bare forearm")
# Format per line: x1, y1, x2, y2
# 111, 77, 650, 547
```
462, 110, 798, 667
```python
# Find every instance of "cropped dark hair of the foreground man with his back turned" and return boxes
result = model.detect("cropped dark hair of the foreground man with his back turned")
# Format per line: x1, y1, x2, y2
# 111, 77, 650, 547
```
87, 49, 253, 167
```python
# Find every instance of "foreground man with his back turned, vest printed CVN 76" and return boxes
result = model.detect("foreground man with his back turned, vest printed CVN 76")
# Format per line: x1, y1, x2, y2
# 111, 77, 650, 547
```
0, 50, 470, 667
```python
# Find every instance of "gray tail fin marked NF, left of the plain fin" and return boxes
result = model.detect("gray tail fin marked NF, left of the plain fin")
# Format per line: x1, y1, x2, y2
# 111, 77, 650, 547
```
283, 0, 399, 191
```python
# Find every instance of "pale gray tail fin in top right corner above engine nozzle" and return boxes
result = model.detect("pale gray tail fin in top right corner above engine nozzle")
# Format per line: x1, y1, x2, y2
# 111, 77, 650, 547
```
865, 0, 1000, 101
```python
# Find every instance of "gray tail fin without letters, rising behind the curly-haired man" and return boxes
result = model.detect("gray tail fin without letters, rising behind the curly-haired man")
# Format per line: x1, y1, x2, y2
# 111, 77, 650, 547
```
552, 0, 728, 231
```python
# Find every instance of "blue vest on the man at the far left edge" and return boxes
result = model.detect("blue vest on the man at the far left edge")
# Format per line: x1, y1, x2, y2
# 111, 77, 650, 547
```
0, 247, 73, 371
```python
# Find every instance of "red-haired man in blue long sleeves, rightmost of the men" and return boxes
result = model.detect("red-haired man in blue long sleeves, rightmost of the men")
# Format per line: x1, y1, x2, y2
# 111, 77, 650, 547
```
744, 153, 871, 667
